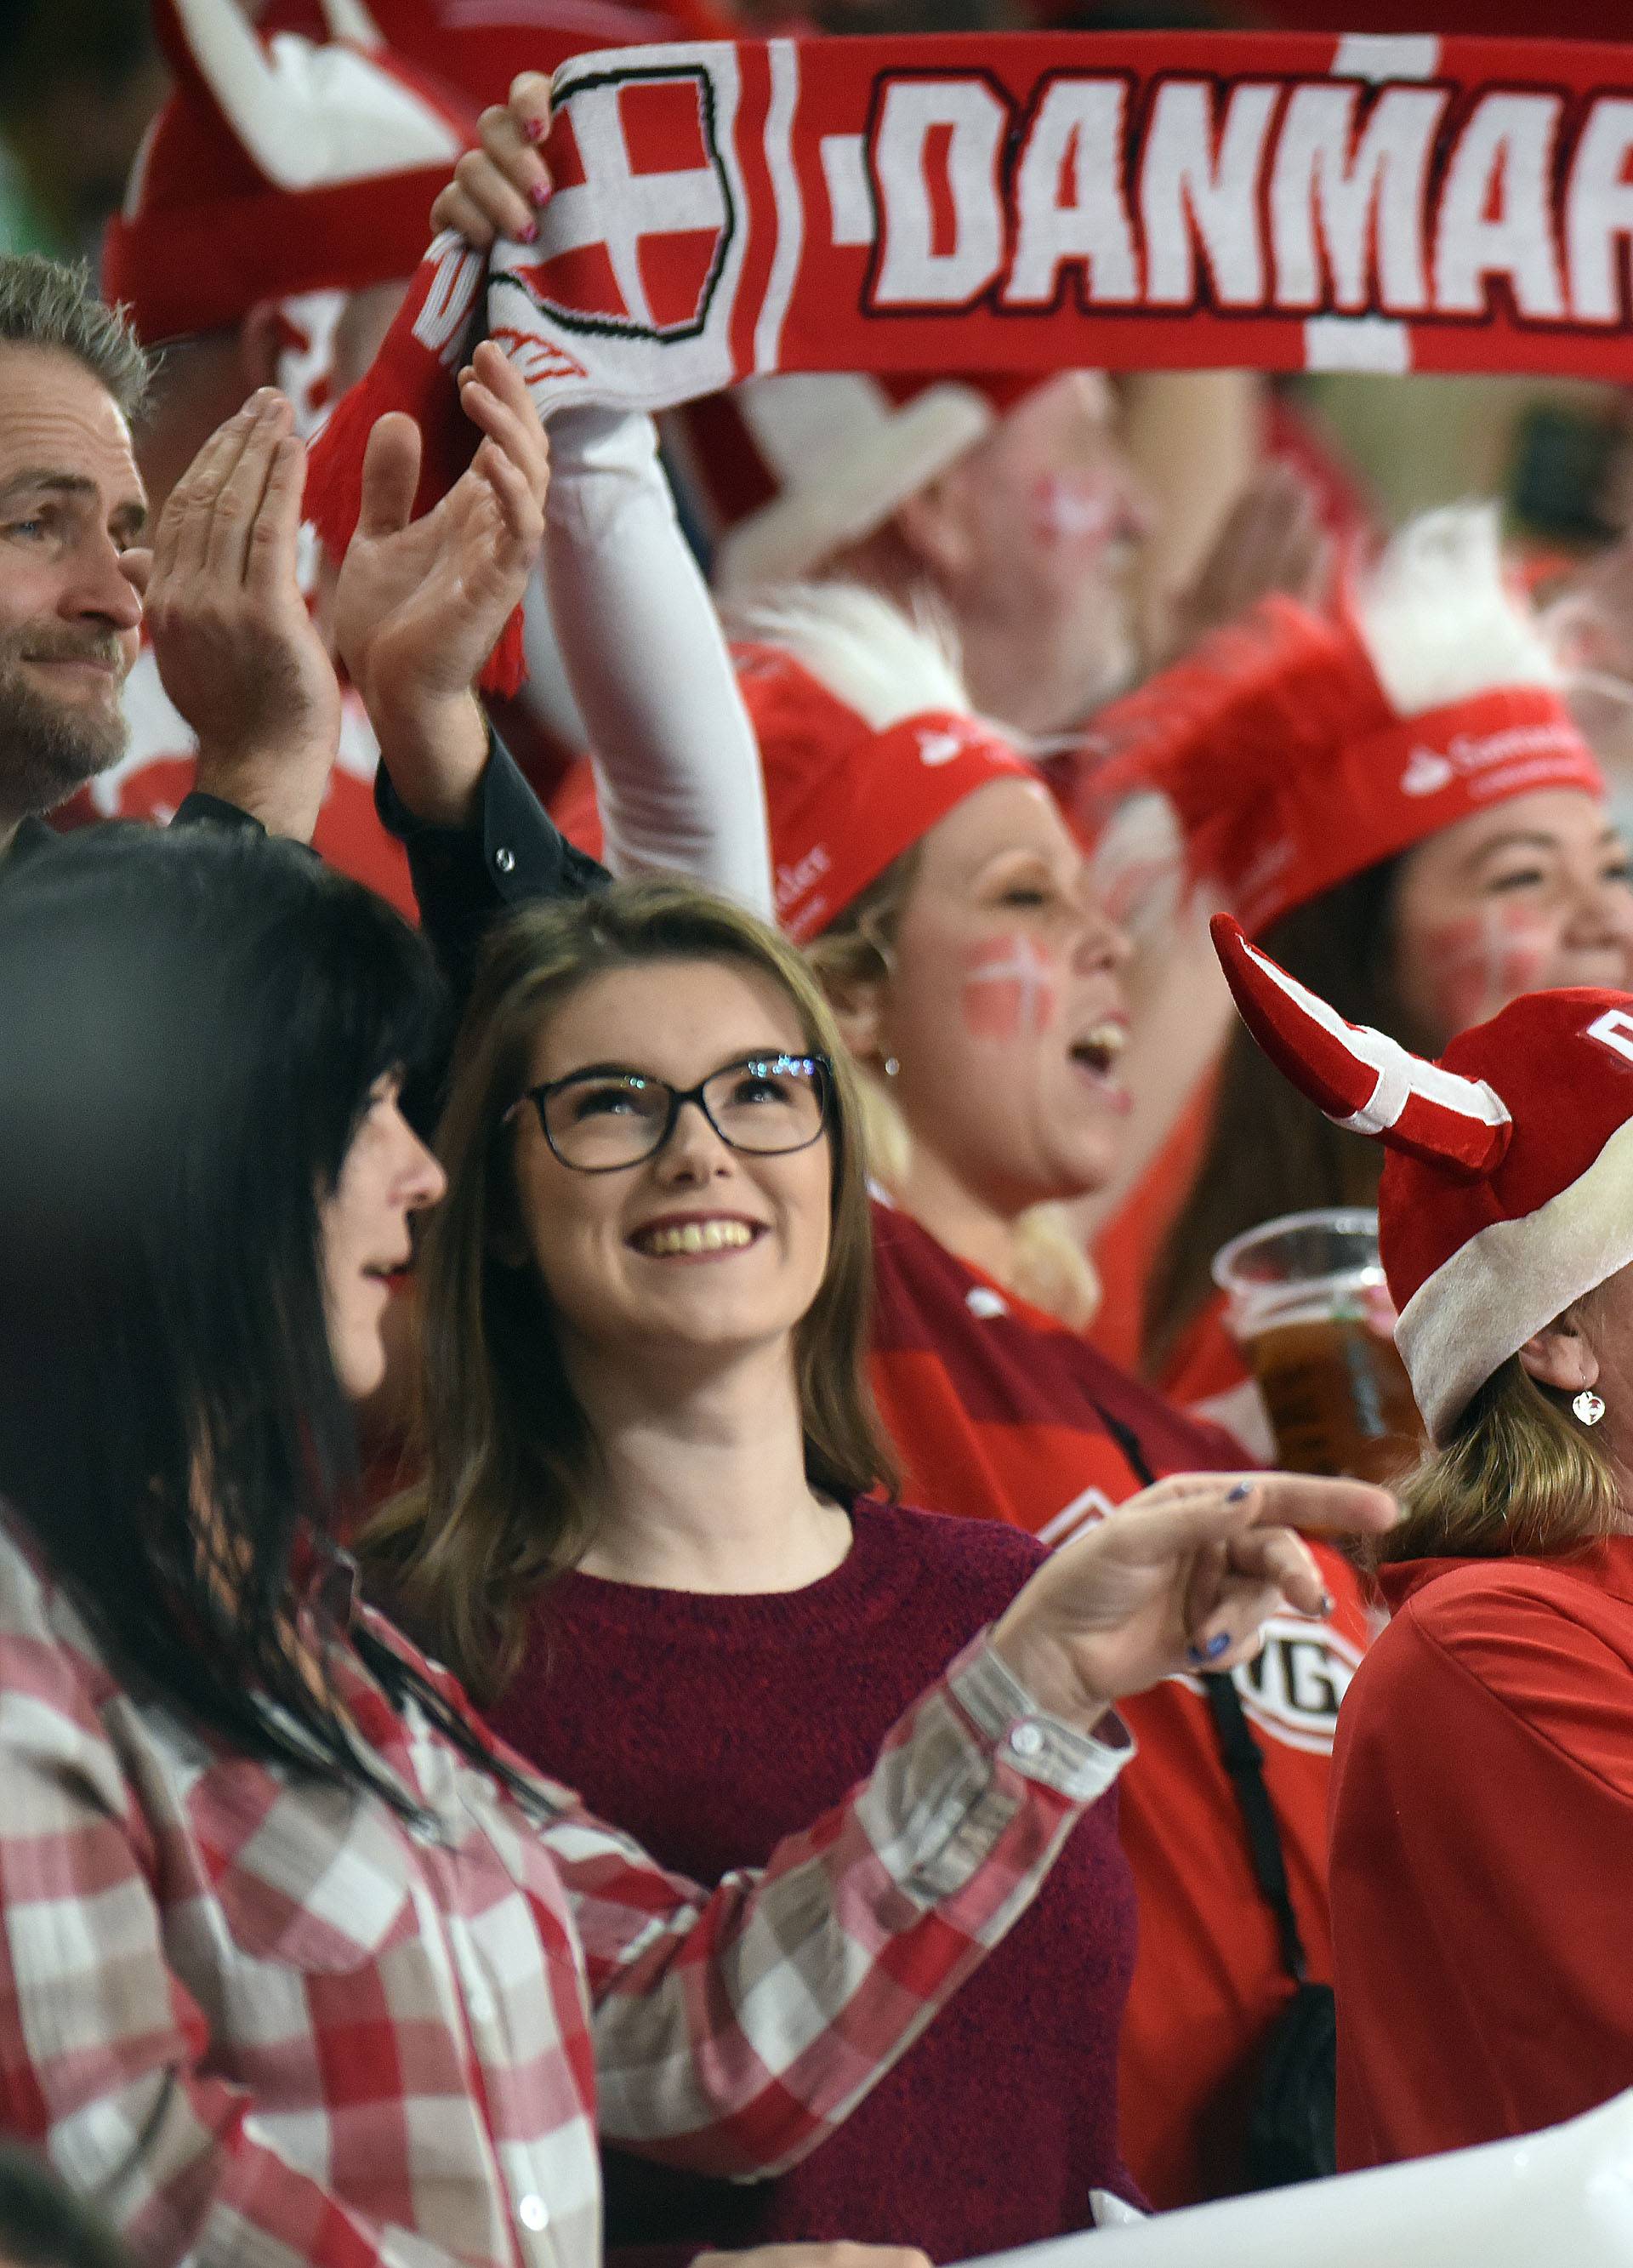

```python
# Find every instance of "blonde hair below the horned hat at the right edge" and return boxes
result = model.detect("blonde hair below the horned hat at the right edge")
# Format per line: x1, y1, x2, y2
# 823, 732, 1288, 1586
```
1374, 1354, 1622, 1565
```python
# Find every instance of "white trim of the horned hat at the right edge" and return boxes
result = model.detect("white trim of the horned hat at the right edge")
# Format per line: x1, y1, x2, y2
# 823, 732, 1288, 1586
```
1395, 1118, 1633, 1447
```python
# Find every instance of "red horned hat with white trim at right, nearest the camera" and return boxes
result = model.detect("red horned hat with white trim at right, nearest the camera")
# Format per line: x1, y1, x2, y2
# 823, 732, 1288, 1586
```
1214, 914, 1633, 1445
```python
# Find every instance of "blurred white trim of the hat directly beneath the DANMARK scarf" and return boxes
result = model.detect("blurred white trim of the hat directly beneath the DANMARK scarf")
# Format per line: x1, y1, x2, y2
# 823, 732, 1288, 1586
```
714, 372, 996, 592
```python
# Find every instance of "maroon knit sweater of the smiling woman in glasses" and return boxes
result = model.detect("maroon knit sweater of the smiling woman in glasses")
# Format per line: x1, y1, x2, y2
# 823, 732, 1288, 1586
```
492, 1502, 1139, 2261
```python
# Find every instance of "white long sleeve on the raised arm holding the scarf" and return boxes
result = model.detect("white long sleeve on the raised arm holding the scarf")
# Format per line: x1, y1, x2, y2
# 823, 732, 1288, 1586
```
544, 408, 771, 920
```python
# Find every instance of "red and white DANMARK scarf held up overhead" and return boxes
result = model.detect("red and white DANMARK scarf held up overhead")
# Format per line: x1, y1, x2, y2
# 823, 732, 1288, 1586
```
487, 34, 1633, 411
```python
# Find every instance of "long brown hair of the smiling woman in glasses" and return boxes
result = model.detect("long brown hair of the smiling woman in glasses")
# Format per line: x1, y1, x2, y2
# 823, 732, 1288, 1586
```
363, 882, 896, 1701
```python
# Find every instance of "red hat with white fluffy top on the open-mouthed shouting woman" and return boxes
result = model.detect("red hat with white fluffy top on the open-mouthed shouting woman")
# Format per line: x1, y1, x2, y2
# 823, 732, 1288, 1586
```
732, 583, 1037, 943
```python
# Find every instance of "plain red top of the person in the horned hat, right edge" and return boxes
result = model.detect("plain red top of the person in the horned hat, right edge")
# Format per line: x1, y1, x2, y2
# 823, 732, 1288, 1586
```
1331, 1538, 1633, 2166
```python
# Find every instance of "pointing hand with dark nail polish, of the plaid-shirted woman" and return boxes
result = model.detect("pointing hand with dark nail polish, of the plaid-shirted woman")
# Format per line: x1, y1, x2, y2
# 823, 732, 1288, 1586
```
993, 1472, 1399, 1730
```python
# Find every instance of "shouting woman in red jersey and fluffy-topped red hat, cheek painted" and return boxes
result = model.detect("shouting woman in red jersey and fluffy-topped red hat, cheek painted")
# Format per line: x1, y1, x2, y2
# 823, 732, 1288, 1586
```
362, 115, 1368, 2222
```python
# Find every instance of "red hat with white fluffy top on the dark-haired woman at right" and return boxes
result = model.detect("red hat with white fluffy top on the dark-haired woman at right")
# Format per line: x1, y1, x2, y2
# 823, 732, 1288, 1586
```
1071, 506, 1603, 937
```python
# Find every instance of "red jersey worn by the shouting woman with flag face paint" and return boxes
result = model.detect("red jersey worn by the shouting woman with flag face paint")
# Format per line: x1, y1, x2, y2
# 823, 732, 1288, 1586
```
871, 1206, 1368, 2207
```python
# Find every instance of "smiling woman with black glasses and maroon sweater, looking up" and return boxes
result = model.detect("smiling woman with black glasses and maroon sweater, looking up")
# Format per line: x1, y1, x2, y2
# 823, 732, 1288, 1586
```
365, 882, 1388, 2259
